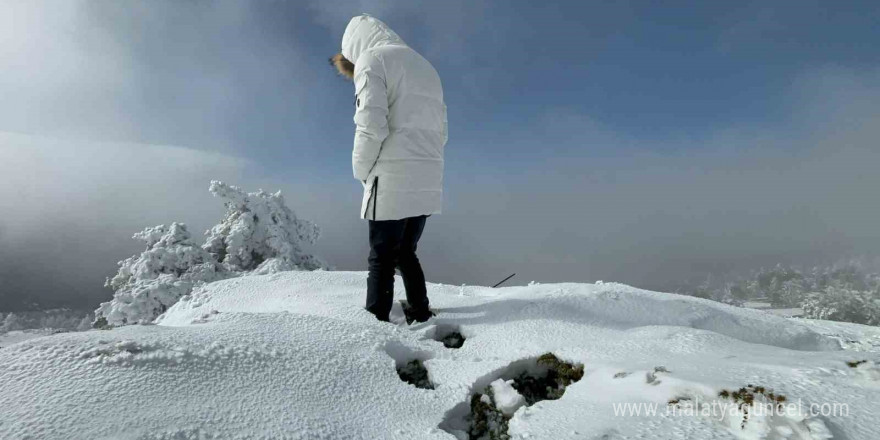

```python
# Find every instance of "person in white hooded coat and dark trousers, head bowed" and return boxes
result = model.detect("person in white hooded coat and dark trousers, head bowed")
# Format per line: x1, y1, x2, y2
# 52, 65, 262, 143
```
331, 15, 448, 322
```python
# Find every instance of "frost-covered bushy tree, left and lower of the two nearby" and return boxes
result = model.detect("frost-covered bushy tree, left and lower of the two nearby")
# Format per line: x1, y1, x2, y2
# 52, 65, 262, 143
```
95, 223, 228, 326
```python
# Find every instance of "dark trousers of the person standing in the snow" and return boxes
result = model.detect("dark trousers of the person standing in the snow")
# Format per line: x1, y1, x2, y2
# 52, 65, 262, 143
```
367, 215, 428, 321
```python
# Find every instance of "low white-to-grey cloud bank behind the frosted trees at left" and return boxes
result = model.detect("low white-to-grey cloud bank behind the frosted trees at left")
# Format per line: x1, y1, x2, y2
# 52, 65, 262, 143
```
0, 133, 251, 310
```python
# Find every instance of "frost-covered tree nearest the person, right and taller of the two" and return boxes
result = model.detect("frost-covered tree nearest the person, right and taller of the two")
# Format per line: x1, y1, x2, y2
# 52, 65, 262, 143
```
204, 180, 325, 272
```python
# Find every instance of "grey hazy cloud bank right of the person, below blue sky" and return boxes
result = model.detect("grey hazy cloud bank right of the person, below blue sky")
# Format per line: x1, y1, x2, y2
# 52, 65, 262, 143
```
423, 68, 880, 288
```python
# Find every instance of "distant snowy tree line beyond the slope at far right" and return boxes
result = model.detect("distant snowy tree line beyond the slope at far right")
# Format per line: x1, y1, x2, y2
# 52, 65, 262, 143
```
679, 261, 880, 325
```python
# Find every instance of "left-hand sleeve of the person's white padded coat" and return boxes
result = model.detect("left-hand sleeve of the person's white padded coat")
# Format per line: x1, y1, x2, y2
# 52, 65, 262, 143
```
351, 52, 388, 181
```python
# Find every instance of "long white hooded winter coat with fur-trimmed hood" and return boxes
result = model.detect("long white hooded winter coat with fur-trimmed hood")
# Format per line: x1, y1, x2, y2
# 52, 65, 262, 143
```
342, 15, 447, 220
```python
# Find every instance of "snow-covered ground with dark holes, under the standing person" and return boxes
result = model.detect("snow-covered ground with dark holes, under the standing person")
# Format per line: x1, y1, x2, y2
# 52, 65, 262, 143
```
0, 271, 880, 440
